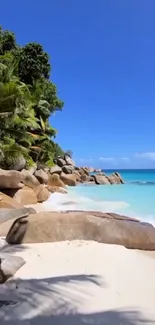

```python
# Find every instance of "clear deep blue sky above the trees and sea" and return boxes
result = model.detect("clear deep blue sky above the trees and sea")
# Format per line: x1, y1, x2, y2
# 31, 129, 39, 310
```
0, 0, 155, 168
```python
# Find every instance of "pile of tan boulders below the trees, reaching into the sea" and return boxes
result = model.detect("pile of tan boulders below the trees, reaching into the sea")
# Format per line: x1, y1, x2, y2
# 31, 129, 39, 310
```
0, 155, 124, 208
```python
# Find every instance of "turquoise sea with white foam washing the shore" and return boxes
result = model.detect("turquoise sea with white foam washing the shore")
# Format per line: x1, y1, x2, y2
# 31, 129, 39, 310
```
40, 169, 155, 225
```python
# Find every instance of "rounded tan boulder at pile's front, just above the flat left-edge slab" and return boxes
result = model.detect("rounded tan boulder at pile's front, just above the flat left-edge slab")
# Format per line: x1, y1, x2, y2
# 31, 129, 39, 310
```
13, 186, 38, 205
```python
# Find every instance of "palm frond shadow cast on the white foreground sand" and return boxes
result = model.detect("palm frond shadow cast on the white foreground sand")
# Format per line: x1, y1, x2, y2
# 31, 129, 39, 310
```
0, 274, 155, 325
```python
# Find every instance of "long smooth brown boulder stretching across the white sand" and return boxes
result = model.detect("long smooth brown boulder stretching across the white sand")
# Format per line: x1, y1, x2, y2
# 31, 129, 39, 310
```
0, 211, 155, 250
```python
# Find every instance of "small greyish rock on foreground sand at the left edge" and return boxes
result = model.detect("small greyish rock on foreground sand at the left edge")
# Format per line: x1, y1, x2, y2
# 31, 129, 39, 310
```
0, 253, 25, 284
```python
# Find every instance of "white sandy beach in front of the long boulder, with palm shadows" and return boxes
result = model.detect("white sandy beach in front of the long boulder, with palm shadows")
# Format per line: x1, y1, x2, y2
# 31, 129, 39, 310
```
0, 241, 155, 325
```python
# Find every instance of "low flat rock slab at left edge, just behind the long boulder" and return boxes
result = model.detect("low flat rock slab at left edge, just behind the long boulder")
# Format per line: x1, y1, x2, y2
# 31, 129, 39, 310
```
0, 207, 36, 224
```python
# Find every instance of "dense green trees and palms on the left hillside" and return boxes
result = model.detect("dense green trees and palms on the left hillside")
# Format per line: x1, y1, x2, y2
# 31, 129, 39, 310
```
0, 27, 72, 169
